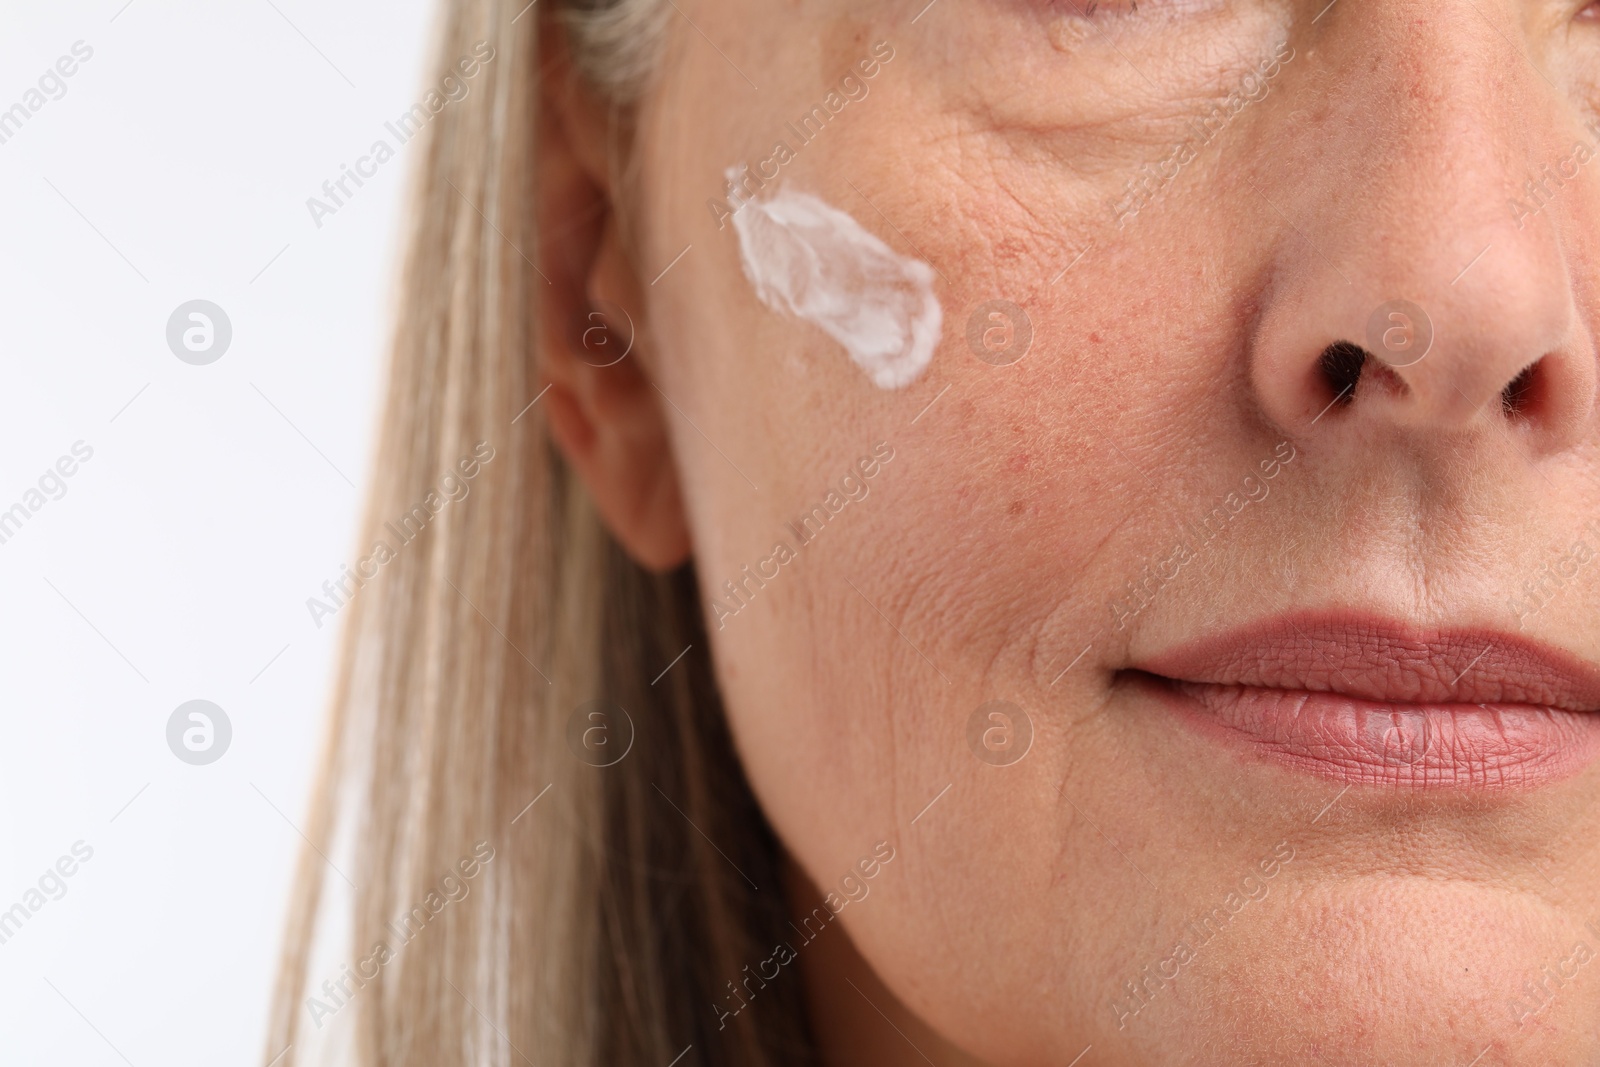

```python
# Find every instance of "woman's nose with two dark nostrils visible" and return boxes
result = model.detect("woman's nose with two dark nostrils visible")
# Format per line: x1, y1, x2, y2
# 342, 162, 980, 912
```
1250, 0, 1600, 453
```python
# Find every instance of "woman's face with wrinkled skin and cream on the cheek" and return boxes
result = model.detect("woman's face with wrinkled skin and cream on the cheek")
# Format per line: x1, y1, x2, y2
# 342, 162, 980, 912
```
620, 0, 1600, 1064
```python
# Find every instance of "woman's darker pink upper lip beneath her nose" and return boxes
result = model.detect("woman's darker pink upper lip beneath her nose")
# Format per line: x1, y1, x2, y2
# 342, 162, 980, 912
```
1131, 613, 1600, 712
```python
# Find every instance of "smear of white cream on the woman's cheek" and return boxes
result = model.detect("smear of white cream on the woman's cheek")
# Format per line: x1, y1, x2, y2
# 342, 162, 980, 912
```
733, 189, 944, 389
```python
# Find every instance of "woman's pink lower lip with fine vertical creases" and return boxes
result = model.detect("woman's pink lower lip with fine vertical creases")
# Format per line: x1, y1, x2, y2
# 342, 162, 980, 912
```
1160, 681, 1600, 790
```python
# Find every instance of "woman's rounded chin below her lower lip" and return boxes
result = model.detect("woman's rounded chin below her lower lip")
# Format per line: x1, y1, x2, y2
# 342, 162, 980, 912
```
1120, 870, 1600, 1067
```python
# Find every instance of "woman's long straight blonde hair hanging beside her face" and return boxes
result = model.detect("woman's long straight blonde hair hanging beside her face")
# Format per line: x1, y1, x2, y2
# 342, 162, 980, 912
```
264, 0, 811, 1067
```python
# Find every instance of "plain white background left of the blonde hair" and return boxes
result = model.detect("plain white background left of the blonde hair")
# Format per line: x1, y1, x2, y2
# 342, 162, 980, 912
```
0, 0, 432, 1067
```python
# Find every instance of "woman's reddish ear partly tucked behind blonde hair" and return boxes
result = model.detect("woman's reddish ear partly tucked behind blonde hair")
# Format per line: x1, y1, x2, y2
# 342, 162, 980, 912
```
534, 22, 690, 571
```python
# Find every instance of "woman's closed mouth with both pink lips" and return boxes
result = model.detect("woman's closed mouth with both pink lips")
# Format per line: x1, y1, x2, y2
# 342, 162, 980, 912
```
1130, 613, 1600, 790
